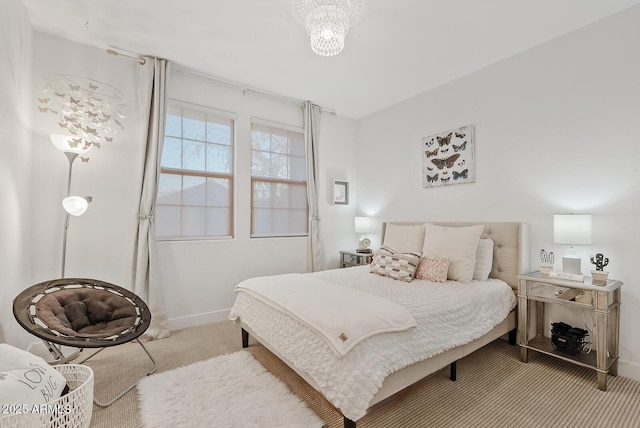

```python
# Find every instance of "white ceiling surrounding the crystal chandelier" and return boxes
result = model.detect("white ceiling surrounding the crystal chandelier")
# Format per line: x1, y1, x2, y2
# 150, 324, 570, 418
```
22, 0, 640, 119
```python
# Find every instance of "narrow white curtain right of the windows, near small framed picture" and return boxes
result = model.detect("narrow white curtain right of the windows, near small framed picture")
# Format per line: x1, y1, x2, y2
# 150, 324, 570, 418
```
303, 101, 323, 272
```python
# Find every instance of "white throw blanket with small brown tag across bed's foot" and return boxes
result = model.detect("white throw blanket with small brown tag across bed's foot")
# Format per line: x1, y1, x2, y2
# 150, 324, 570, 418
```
236, 273, 416, 357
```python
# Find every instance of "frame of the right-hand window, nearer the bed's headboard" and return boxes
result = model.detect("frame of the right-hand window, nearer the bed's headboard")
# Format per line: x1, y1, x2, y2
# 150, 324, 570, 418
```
249, 117, 309, 239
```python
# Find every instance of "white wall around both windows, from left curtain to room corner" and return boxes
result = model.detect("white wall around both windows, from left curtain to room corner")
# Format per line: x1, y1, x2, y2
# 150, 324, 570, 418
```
159, 72, 356, 329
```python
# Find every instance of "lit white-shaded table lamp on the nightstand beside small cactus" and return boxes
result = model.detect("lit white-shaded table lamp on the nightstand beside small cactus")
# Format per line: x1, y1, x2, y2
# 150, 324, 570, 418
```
553, 214, 591, 275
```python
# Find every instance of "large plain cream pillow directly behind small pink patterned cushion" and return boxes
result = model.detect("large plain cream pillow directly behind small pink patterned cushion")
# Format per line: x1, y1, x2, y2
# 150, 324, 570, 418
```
422, 223, 484, 282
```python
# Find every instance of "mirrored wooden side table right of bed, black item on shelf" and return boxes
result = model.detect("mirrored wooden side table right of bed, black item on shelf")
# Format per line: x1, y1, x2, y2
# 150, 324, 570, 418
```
518, 272, 623, 391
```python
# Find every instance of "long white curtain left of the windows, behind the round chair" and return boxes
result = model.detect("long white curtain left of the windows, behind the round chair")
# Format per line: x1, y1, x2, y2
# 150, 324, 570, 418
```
133, 57, 170, 339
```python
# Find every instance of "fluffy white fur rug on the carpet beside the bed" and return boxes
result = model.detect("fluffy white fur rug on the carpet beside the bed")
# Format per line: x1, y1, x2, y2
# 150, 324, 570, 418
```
138, 351, 323, 428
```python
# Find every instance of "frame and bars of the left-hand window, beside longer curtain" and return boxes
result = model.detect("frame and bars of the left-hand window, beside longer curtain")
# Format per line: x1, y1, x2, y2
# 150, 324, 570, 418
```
156, 98, 238, 242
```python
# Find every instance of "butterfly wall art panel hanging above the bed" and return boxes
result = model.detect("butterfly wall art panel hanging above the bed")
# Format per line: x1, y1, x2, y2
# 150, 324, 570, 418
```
421, 125, 476, 187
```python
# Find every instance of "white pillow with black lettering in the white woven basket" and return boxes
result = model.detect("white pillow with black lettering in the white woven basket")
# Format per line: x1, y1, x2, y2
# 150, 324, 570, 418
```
0, 343, 67, 411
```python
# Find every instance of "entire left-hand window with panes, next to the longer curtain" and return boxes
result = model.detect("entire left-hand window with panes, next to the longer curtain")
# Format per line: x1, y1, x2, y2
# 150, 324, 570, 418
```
155, 101, 234, 239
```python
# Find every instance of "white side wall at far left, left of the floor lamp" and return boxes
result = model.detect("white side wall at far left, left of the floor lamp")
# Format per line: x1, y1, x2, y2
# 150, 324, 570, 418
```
0, 0, 33, 347
